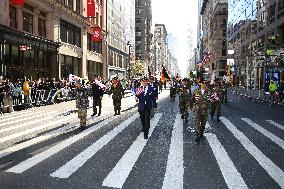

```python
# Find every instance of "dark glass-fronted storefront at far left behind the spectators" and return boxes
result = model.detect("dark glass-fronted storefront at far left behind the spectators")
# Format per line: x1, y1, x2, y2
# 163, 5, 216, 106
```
0, 25, 60, 81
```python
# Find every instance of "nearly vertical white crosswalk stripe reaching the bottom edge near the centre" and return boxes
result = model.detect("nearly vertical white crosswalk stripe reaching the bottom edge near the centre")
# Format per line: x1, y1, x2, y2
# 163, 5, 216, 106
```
162, 114, 184, 189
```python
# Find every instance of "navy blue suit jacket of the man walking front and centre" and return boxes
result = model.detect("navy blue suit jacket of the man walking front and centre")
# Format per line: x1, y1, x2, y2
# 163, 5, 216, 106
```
136, 86, 155, 110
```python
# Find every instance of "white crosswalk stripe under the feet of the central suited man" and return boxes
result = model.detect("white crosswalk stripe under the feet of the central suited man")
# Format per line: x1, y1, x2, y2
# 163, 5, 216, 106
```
103, 113, 162, 188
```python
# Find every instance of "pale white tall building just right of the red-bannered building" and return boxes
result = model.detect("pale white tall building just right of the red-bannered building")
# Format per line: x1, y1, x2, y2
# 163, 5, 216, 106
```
107, 0, 135, 79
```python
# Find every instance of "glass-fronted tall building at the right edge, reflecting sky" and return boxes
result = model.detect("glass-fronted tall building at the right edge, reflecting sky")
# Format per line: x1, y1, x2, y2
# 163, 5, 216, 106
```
228, 0, 284, 89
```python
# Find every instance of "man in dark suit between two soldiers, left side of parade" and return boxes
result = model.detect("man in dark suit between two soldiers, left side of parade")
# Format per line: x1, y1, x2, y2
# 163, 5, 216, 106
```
92, 75, 104, 116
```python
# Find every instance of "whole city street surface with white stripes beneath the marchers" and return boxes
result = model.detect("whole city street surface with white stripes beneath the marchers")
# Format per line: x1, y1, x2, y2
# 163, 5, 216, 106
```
0, 90, 284, 189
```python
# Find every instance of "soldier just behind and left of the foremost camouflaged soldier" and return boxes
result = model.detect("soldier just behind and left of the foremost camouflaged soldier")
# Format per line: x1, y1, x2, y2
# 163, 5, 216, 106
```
178, 78, 191, 122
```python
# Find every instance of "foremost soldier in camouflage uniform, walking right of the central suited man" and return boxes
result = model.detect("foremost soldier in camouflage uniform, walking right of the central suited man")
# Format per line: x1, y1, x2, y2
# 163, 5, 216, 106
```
190, 82, 210, 142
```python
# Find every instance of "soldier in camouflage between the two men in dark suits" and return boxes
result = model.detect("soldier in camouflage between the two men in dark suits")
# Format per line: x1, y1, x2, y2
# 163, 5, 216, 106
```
109, 77, 124, 115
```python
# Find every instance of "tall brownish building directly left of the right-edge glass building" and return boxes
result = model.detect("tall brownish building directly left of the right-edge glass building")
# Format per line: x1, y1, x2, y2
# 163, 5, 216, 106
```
201, 0, 228, 78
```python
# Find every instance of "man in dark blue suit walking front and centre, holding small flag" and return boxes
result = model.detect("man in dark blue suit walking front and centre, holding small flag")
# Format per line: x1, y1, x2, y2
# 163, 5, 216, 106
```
136, 77, 154, 139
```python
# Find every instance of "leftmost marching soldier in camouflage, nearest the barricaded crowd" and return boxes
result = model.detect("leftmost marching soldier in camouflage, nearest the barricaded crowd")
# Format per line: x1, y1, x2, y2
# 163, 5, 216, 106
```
76, 81, 89, 128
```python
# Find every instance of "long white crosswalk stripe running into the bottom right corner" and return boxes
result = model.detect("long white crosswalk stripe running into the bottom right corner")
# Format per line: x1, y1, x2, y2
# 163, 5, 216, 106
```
220, 117, 284, 188
